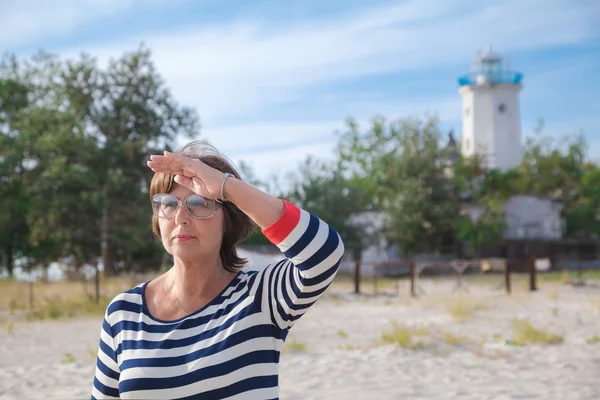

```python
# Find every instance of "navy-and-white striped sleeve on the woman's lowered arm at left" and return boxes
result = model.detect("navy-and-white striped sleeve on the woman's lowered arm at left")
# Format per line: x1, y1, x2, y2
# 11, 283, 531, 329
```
91, 309, 120, 400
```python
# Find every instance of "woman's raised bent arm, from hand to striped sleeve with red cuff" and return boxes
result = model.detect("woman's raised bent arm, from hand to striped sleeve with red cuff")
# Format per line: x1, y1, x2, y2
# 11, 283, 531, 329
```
148, 152, 344, 329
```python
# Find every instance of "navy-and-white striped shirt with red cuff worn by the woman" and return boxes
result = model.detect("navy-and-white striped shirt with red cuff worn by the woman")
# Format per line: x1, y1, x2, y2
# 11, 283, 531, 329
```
92, 202, 344, 399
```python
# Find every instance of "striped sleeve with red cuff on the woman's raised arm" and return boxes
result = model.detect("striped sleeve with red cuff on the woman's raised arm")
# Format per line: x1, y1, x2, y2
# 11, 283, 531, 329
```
263, 200, 344, 329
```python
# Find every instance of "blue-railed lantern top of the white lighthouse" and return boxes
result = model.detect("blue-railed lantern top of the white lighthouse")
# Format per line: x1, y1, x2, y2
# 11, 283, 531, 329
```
458, 46, 523, 86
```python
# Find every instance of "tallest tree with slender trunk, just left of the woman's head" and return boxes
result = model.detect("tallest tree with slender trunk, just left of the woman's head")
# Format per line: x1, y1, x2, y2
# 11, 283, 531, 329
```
63, 43, 198, 275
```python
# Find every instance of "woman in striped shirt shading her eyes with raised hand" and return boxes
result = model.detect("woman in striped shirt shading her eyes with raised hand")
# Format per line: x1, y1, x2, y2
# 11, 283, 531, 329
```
92, 142, 344, 399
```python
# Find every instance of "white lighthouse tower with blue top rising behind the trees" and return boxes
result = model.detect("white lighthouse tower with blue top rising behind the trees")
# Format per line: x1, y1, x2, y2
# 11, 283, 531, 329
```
458, 47, 523, 171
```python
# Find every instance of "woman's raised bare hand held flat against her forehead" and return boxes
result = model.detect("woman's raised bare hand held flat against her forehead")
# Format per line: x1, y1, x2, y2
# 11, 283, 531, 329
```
147, 151, 225, 199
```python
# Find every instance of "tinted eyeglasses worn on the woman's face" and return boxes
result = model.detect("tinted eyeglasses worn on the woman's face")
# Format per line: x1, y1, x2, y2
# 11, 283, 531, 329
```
152, 193, 223, 219
